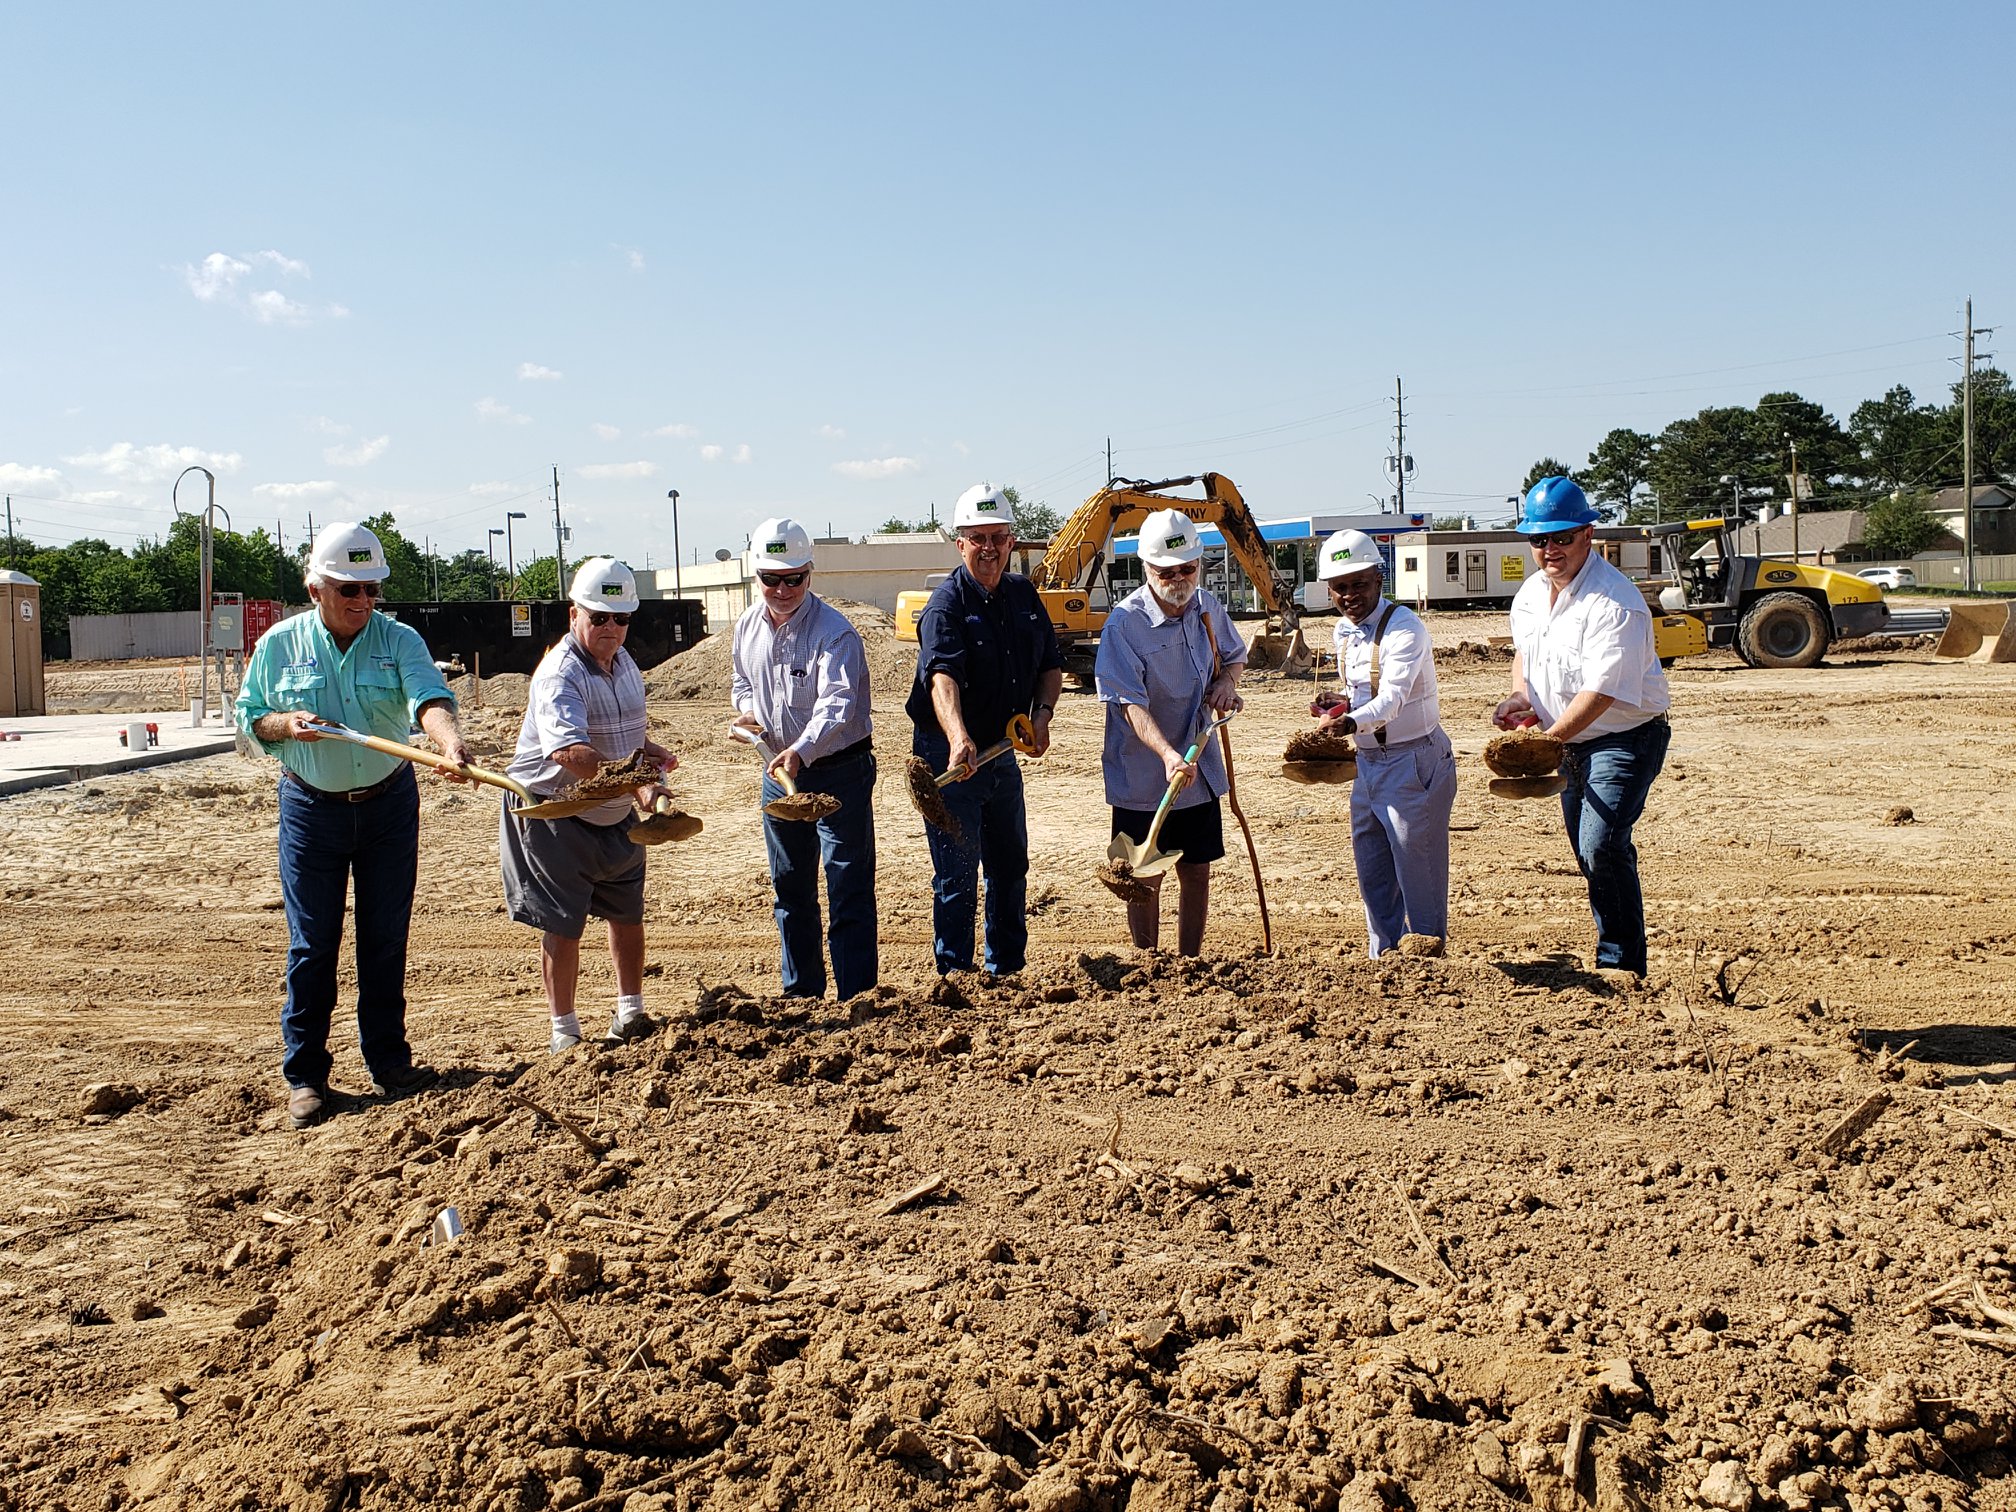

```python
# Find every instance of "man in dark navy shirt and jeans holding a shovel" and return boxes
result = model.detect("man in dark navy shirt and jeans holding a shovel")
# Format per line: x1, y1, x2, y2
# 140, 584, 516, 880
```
903, 484, 1064, 976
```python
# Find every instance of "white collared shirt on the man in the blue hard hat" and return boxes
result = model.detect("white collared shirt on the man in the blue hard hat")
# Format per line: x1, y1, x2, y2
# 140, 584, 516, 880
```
1512, 552, 1671, 744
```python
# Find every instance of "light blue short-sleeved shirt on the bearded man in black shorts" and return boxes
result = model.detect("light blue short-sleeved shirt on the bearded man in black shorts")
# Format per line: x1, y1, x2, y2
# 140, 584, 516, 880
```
1093, 587, 1246, 808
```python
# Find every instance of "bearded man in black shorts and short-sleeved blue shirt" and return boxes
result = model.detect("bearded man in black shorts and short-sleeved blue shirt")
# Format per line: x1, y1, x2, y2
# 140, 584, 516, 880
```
1093, 510, 1246, 956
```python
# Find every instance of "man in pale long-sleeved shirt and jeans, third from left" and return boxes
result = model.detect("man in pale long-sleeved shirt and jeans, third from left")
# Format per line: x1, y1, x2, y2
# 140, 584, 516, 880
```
730, 518, 881, 1002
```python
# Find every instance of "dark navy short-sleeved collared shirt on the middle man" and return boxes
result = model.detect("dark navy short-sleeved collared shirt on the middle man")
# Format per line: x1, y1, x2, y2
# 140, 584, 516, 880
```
903, 566, 1064, 760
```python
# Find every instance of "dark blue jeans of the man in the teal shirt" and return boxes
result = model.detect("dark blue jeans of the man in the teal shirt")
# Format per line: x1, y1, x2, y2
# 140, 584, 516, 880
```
280, 766, 419, 1087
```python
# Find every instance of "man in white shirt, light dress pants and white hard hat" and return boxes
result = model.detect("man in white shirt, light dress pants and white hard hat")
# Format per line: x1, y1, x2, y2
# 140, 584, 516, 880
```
1316, 530, 1456, 956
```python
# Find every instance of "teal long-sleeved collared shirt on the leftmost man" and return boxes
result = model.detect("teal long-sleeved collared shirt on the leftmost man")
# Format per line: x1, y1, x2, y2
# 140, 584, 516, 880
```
232, 605, 456, 792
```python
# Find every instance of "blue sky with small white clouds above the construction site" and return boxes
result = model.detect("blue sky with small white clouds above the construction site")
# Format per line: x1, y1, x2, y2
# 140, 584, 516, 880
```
0, 0, 2016, 564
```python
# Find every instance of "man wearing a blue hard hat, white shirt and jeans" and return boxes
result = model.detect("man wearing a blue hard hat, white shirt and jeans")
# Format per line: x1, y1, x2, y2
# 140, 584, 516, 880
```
1492, 478, 1673, 976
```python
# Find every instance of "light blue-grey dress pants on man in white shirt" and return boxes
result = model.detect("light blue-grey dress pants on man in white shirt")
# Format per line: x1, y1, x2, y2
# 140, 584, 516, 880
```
1351, 726, 1456, 956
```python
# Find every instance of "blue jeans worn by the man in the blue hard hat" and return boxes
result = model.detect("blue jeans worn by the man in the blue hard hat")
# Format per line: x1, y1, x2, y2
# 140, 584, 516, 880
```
1560, 720, 1673, 976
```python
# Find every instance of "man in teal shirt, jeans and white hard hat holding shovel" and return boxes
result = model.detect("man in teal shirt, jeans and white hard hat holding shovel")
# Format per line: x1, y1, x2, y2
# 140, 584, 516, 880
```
236, 522, 470, 1129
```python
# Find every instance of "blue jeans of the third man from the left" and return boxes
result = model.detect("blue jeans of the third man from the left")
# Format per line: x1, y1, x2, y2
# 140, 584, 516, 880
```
762, 752, 881, 1002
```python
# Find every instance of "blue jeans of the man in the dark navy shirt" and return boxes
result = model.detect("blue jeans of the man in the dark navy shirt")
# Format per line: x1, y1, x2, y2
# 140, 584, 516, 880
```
913, 730, 1028, 976
